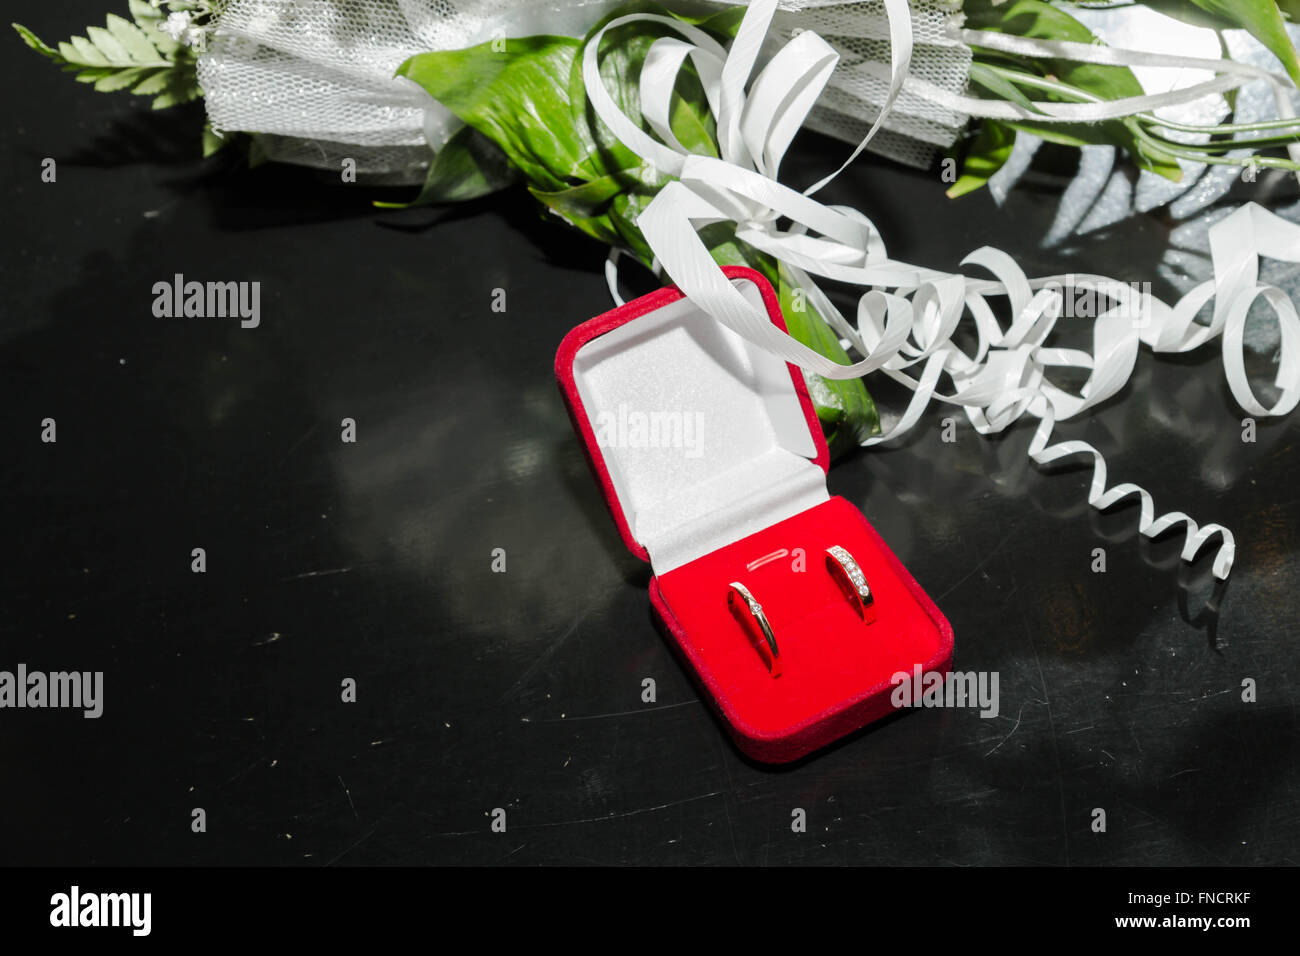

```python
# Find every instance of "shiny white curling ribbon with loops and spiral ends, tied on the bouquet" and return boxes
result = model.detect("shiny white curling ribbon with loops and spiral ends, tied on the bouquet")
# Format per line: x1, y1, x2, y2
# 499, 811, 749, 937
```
582, 0, 1300, 579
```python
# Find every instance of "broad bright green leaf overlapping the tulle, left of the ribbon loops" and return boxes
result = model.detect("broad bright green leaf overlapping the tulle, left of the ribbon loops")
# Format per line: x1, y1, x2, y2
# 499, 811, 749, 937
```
397, 36, 588, 190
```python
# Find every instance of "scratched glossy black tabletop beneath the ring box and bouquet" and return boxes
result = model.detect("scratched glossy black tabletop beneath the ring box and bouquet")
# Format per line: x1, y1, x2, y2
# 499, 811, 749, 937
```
0, 5, 1300, 865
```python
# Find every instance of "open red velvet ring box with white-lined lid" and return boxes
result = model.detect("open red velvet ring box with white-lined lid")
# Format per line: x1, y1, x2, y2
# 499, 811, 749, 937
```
555, 267, 953, 763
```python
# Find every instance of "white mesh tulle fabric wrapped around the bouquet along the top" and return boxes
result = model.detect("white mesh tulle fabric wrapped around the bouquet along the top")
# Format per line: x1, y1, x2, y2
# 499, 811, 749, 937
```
199, 0, 971, 183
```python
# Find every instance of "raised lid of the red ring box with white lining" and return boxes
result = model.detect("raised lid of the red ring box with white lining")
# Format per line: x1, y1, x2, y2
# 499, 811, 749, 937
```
556, 267, 829, 574
